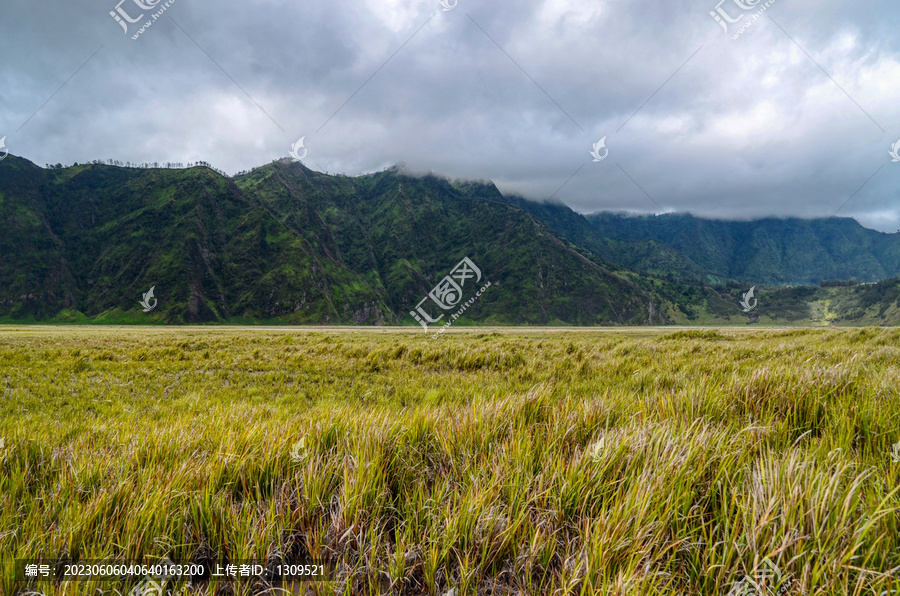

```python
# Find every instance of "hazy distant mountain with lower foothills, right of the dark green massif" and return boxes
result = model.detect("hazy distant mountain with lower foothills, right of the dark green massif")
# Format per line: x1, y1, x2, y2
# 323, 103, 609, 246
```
474, 196, 900, 325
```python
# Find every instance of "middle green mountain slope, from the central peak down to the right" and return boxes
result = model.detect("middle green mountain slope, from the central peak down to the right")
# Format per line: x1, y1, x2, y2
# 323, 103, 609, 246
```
237, 161, 651, 325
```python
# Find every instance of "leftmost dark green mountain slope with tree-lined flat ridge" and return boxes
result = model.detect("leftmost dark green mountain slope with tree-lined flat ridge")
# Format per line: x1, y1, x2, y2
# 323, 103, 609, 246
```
0, 157, 389, 323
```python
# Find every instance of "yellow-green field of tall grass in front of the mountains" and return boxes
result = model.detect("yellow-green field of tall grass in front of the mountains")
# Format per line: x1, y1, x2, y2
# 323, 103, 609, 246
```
0, 327, 900, 595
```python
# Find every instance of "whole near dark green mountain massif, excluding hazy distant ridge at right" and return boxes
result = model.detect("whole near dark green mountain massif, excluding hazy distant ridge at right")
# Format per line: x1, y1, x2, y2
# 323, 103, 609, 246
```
0, 156, 663, 325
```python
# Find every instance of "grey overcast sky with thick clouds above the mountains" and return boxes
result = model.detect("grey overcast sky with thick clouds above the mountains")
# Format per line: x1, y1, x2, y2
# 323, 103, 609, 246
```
0, 0, 900, 232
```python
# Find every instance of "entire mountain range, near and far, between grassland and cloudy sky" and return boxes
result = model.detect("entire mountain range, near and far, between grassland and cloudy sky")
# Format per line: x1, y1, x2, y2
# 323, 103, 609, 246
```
0, 156, 900, 325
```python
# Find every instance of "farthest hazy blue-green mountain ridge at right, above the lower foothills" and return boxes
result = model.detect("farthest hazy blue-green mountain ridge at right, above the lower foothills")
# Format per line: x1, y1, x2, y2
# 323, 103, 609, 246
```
587, 213, 900, 285
